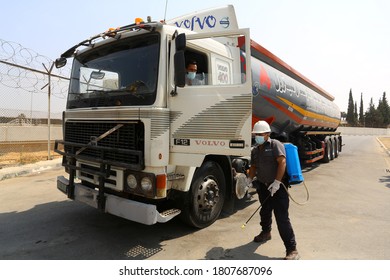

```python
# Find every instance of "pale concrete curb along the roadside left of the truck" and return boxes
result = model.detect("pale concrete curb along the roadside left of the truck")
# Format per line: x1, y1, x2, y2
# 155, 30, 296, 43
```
0, 158, 62, 181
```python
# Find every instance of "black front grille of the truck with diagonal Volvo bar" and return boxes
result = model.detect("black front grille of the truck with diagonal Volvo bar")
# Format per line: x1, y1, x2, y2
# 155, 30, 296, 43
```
64, 121, 144, 168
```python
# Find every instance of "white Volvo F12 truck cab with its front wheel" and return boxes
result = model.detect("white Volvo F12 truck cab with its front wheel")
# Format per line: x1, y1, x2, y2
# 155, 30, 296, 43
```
55, 6, 252, 228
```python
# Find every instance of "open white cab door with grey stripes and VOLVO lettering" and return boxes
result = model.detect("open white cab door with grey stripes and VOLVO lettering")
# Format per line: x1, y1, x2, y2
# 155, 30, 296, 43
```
168, 29, 252, 166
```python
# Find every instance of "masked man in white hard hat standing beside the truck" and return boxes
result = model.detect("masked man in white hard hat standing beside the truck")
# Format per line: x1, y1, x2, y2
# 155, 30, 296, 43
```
248, 121, 299, 260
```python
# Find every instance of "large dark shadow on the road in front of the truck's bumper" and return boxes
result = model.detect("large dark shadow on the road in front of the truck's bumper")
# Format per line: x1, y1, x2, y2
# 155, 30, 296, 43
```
0, 201, 196, 260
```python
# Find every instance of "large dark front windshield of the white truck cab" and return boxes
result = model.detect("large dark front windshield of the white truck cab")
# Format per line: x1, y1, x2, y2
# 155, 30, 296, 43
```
67, 34, 159, 109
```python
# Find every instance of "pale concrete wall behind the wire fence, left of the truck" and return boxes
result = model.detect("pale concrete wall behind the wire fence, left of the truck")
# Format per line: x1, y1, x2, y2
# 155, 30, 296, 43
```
0, 125, 62, 142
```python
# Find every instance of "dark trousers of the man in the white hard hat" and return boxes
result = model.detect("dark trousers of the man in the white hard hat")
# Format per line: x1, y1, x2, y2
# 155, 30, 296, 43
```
256, 181, 297, 250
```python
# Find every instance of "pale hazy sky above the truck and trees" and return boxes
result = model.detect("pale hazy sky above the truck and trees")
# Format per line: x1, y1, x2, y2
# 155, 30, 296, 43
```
0, 0, 390, 112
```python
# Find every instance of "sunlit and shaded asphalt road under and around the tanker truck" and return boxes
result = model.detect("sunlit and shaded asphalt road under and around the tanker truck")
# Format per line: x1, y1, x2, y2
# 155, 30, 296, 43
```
0, 136, 390, 260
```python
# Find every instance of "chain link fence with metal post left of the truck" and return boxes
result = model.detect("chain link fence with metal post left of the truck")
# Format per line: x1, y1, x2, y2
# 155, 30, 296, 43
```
0, 39, 70, 168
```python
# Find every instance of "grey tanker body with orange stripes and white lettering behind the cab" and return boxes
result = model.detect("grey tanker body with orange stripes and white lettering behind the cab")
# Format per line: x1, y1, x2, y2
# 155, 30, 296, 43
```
243, 42, 340, 135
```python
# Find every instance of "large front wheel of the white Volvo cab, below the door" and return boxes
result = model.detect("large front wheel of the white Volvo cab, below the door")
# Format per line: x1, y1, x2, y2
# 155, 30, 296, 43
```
181, 161, 226, 228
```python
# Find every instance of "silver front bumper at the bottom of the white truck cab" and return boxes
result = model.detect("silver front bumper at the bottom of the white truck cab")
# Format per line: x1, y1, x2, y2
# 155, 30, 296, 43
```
57, 176, 181, 225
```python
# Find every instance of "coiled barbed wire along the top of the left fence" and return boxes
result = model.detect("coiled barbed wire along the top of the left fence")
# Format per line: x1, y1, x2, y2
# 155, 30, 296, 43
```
0, 39, 70, 98
